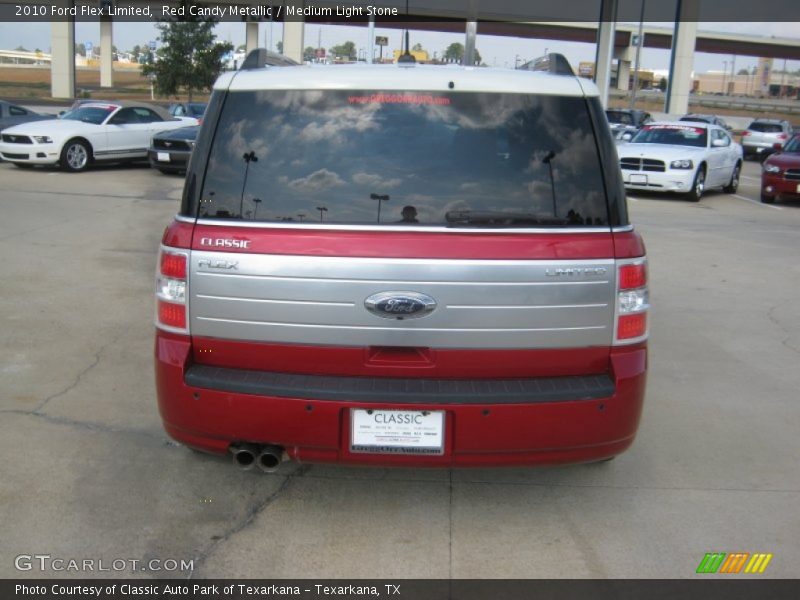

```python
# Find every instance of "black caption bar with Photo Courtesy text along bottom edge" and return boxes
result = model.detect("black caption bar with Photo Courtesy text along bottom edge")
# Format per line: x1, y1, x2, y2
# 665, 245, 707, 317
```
0, 575, 800, 600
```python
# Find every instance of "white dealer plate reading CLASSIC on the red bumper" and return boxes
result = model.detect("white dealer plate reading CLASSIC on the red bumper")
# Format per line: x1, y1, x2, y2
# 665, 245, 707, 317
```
350, 408, 444, 455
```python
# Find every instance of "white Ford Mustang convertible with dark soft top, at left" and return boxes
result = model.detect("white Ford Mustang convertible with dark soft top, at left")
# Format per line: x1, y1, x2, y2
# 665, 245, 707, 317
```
0, 101, 197, 171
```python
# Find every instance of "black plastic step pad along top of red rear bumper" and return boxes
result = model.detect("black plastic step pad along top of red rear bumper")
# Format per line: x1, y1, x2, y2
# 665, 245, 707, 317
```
185, 365, 615, 404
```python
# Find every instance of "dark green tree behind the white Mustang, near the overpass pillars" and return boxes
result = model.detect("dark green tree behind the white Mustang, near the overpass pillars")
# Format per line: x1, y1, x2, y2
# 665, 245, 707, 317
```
142, 11, 233, 101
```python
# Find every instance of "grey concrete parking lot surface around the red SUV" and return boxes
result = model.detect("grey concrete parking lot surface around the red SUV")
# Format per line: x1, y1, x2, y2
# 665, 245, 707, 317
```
0, 163, 800, 578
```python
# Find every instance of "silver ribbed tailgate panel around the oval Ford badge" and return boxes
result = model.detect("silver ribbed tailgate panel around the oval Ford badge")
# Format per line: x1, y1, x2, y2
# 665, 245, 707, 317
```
189, 250, 616, 349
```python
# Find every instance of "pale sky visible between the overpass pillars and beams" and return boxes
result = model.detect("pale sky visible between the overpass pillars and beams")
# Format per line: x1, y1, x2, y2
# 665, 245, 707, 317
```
0, 22, 800, 73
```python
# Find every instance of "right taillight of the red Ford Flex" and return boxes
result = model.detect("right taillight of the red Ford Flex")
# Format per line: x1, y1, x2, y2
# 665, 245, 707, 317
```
614, 258, 650, 344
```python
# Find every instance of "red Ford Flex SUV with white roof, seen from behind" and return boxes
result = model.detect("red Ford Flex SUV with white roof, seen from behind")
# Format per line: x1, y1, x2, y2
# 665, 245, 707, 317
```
155, 51, 649, 471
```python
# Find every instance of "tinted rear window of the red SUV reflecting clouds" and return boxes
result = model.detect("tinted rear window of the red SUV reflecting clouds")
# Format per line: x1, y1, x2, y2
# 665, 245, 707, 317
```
198, 90, 608, 227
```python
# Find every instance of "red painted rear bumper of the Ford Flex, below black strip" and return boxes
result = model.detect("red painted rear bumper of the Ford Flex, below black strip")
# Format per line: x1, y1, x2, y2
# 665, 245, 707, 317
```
155, 331, 647, 467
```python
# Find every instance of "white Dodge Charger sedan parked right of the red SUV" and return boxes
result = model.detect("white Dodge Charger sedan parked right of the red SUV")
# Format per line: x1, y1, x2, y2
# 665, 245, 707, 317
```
617, 122, 742, 202
